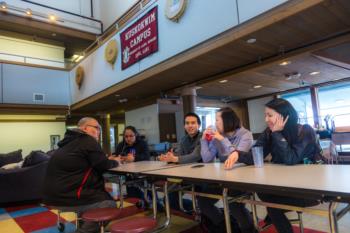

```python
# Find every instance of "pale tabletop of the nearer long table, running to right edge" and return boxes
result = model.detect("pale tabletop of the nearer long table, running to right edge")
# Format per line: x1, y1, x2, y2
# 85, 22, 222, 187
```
142, 163, 350, 200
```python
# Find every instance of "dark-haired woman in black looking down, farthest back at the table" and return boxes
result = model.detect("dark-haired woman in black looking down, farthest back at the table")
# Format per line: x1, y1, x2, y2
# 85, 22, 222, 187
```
114, 126, 150, 205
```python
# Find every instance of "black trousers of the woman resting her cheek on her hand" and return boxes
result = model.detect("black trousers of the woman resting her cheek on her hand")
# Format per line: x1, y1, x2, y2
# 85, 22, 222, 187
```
258, 193, 319, 233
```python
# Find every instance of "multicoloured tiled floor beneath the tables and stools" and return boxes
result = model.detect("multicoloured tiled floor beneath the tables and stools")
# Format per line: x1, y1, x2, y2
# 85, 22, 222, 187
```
0, 200, 350, 233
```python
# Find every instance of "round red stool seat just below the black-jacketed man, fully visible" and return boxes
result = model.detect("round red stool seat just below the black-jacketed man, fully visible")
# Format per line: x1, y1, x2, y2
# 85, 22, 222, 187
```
82, 208, 122, 222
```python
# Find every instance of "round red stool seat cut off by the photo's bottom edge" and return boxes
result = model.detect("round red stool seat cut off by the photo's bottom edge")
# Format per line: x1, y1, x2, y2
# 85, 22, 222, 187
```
110, 217, 157, 233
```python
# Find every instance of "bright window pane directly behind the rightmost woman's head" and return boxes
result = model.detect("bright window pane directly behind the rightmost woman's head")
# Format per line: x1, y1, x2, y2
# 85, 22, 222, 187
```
281, 90, 314, 125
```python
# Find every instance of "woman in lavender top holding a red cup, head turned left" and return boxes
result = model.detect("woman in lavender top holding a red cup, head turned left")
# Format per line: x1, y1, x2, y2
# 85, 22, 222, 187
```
198, 107, 256, 233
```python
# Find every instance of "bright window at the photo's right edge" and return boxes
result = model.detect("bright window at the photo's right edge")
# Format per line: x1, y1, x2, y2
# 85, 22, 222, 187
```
318, 82, 350, 127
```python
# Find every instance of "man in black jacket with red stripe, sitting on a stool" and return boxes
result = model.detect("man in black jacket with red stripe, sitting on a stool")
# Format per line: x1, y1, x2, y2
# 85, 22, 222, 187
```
44, 117, 119, 232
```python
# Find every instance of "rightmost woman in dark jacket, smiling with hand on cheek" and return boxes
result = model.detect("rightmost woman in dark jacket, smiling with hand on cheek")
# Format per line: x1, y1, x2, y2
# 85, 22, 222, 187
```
238, 99, 320, 233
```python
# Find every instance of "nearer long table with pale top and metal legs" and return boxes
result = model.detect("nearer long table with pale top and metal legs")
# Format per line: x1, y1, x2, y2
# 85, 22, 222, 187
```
140, 163, 350, 233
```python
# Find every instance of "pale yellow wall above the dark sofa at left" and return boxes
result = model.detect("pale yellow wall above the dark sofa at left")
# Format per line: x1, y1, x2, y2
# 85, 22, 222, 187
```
0, 115, 66, 156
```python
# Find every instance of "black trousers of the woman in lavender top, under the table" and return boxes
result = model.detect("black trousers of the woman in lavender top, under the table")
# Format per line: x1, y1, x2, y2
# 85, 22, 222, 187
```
197, 185, 255, 233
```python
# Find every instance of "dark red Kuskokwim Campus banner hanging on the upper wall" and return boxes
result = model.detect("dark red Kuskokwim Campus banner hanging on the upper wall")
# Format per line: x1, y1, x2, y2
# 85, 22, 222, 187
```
120, 6, 158, 70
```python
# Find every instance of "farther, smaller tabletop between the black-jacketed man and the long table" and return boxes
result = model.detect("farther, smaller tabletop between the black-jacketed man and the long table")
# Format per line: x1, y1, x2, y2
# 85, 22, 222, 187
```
109, 161, 181, 173
